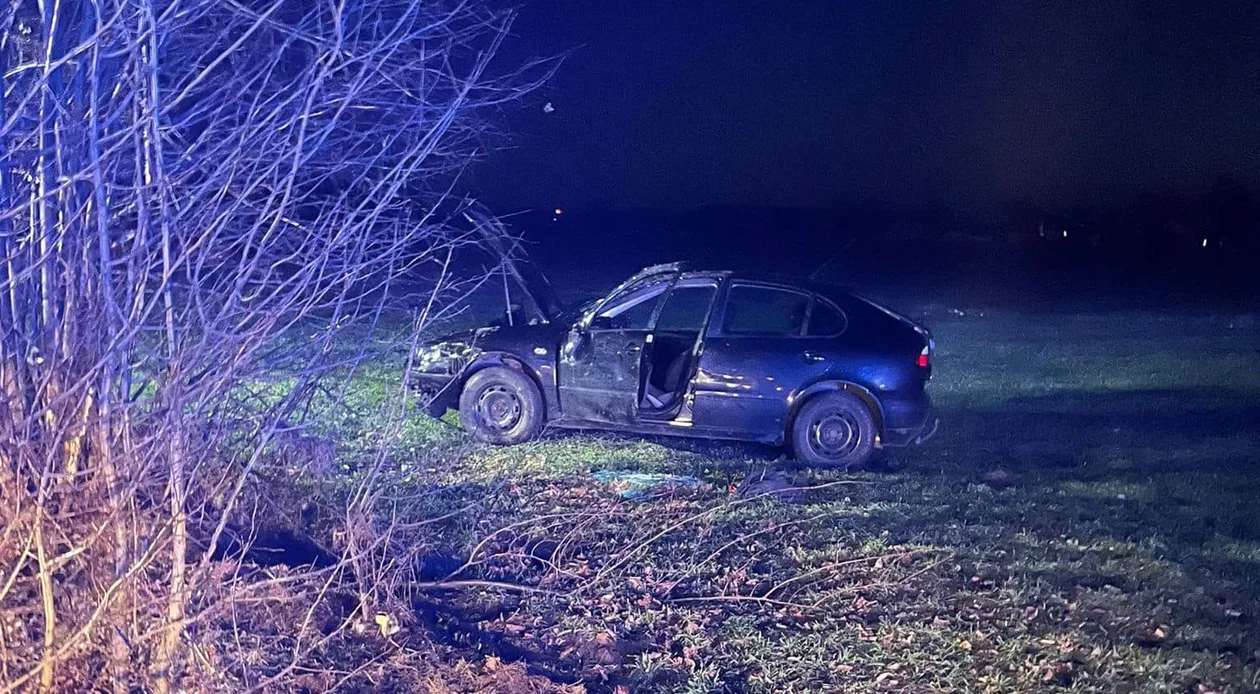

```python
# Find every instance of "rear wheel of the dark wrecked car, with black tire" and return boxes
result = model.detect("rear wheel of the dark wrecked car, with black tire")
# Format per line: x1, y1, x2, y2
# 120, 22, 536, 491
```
791, 390, 877, 469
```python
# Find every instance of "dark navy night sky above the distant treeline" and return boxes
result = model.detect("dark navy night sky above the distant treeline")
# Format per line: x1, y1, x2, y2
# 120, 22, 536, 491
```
478, 0, 1260, 215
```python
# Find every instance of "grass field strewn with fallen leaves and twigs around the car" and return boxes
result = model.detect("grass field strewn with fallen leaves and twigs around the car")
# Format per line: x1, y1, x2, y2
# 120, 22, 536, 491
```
275, 298, 1260, 693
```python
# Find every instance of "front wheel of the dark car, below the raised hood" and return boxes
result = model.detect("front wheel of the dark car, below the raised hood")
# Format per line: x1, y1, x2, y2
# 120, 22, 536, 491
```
460, 367, 543, 446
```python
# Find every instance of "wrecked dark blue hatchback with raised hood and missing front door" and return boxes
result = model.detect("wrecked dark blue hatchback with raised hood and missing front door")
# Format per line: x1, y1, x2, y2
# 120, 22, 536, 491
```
417, 263, 936, 467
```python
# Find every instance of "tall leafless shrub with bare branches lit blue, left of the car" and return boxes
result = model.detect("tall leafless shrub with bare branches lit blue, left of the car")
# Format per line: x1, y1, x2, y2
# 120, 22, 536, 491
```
0, 0, 552, 691
